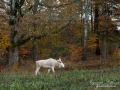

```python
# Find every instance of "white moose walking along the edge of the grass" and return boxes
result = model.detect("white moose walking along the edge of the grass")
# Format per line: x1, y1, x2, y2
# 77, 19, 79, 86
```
35, 58, 64, 75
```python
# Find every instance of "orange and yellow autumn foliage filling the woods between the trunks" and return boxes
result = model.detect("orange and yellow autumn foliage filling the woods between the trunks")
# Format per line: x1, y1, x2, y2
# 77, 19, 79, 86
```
0, 0, 120, 71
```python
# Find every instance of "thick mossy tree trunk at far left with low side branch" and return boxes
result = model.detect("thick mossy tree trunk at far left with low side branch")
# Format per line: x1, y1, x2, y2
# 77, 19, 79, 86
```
9, 0, 25, 65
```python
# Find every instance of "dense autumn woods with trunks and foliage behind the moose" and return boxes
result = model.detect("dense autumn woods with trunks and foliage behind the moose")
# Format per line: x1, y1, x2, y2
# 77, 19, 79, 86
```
0, 0, 120, 70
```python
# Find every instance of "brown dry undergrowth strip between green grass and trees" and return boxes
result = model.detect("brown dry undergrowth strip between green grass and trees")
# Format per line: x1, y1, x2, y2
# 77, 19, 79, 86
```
0, 56, 120, 74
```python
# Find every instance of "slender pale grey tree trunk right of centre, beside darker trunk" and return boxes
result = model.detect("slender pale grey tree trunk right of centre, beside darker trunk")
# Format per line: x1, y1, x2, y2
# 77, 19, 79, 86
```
82, 0, 89, 60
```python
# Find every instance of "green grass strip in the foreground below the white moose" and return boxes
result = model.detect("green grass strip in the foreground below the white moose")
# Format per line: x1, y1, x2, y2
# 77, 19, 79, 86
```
0, 68, 120, 90
